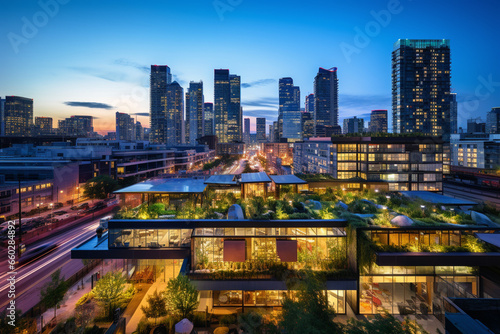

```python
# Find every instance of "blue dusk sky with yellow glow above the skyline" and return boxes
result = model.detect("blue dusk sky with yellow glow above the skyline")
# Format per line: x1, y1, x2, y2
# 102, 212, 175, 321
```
0, 0, 500, 132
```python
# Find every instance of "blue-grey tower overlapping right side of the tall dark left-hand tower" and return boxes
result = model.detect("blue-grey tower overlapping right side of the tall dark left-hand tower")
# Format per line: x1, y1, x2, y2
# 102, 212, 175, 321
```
165, 81, 185, 145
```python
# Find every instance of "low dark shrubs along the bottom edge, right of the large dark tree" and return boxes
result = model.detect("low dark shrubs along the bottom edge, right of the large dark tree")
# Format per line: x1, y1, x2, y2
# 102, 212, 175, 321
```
344, 313, 429, 334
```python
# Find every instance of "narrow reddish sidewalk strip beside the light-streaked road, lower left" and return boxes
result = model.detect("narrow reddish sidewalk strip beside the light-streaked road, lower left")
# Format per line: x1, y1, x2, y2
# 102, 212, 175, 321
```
36, 260, 115, 331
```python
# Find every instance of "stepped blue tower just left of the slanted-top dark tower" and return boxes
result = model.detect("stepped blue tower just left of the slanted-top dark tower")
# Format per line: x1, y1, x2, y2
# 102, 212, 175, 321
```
278, 78, 302, 141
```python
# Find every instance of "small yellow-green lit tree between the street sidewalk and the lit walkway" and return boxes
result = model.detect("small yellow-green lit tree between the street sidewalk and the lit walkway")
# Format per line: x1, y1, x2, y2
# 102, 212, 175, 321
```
94, 272, 125, 317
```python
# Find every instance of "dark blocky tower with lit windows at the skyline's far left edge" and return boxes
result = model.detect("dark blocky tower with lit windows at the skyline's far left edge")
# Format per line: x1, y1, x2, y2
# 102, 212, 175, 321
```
1, 96, 33, 136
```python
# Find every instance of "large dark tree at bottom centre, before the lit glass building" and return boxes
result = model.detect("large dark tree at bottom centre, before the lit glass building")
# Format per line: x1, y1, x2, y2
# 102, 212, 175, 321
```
280, 270, 341, 334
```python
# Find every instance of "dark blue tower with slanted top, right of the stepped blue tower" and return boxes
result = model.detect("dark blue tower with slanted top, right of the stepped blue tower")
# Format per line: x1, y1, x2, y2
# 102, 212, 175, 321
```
314, 67, 339, 136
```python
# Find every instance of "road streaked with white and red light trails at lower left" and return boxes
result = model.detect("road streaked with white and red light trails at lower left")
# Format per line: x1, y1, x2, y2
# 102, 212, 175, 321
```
0, 219, 99, 311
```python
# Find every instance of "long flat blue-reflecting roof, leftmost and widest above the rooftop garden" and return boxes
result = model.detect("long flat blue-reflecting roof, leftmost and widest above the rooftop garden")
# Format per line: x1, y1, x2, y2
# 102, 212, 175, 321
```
115, 179, 207, 194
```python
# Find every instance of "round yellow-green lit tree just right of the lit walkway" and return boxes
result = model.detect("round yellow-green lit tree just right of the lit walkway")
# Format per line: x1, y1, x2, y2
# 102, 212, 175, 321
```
164, 274, 199, 318
